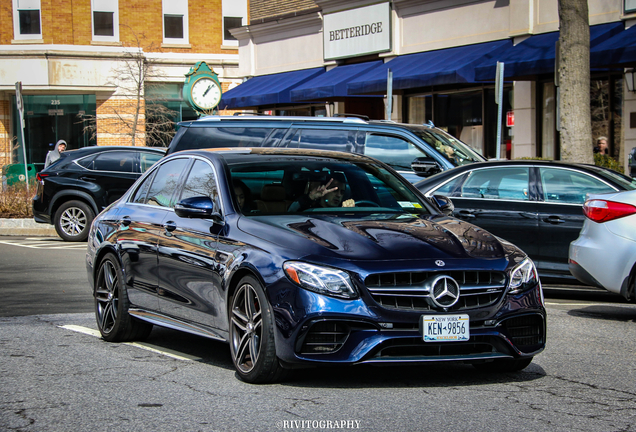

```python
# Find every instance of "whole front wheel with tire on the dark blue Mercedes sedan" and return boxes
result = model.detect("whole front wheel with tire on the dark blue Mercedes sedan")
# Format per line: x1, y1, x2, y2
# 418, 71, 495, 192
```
228, 276, 286, 384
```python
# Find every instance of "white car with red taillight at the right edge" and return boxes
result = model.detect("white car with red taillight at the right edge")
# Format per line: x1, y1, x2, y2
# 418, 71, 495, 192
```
569, 191, 636, 301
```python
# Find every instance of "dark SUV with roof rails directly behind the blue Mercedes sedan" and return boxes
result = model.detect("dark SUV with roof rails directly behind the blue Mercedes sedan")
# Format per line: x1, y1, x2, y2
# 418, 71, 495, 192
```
166, 114, 486, 183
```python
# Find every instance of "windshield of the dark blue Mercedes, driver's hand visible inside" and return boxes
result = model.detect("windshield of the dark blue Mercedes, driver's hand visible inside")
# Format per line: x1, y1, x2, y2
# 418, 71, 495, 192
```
230, 157, 431, 216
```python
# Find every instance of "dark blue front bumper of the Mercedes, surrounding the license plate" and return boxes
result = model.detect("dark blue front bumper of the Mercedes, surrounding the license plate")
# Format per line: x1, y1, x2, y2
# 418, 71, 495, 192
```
274, 284, 546, 366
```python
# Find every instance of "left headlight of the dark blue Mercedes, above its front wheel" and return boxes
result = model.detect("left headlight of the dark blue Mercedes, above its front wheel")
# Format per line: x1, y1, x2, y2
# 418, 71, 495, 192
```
283, 261, 358, 299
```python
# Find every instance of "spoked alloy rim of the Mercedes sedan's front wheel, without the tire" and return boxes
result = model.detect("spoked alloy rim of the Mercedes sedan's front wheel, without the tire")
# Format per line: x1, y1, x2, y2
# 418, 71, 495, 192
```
230, 284, 263, 373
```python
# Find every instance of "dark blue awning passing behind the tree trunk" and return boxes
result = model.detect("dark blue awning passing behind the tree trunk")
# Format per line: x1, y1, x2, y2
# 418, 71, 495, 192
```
475, 23, 623, 81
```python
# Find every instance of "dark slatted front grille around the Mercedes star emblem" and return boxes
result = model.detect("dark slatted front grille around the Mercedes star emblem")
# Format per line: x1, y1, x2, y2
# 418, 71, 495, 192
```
364, 271, 506, 312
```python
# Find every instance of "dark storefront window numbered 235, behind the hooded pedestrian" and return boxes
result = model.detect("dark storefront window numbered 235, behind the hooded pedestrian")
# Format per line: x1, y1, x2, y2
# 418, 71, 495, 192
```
11, 95, 96, 169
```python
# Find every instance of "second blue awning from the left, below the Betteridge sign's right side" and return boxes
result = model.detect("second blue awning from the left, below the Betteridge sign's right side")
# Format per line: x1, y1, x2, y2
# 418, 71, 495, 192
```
291, 60, 383, 101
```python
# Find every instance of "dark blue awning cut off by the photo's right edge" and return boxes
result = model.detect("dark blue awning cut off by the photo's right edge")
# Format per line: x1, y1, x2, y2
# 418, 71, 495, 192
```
590, 25, 636, 68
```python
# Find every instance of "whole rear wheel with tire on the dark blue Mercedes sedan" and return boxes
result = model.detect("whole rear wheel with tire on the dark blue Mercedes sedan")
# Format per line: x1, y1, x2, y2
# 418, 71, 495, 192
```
93, 253, 152, 342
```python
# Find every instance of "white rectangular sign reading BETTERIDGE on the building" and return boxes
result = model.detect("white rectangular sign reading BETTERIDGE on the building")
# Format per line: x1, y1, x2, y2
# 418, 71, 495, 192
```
323, 3, 391, 60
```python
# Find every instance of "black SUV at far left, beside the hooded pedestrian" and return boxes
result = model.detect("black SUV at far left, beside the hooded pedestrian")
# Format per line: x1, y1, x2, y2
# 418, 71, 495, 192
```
33, 147, 165, 241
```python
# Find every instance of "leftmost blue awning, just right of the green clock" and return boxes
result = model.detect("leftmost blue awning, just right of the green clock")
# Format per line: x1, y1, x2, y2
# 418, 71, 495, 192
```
219, 67, 325, 109
